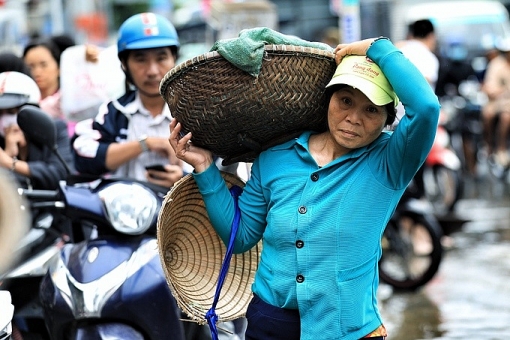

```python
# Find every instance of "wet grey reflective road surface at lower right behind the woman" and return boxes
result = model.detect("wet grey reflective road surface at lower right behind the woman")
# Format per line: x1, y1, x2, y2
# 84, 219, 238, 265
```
379, 176, 510, 340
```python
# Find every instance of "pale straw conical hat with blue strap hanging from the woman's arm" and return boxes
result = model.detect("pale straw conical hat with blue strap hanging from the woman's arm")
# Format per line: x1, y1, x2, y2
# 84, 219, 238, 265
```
157, 172, 261, 324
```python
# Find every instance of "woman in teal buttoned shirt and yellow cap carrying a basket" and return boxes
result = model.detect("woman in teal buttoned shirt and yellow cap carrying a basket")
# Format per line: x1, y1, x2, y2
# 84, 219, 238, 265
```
170, 38, 439, 339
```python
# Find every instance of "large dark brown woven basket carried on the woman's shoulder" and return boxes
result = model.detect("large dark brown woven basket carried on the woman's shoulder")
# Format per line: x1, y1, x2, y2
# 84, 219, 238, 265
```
160, 45, 336, 165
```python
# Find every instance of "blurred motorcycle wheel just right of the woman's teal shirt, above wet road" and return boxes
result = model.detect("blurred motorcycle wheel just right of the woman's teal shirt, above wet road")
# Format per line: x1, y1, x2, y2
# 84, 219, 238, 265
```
379, 212, 443, 291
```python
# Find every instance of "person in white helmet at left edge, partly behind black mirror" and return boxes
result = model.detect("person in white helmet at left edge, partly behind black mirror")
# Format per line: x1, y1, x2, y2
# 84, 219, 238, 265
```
0, 71, 72, 190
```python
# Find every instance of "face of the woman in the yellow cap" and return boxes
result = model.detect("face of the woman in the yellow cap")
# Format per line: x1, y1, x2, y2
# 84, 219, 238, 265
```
328, 86, 388, 150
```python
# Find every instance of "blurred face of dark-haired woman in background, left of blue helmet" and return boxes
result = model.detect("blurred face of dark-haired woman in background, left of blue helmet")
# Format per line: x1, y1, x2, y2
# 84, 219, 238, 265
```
24, 46, 60, 96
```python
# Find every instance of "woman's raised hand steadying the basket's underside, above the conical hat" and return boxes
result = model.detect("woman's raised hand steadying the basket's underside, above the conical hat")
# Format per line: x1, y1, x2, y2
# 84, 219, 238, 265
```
169, 119, 213, 173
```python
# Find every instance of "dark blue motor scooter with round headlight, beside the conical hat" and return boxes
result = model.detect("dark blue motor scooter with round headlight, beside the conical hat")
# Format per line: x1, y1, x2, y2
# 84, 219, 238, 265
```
14, 107, 184, 340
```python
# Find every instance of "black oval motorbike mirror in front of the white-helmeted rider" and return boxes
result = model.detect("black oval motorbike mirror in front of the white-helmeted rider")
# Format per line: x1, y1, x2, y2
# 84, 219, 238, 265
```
18, 105, 57, 150
